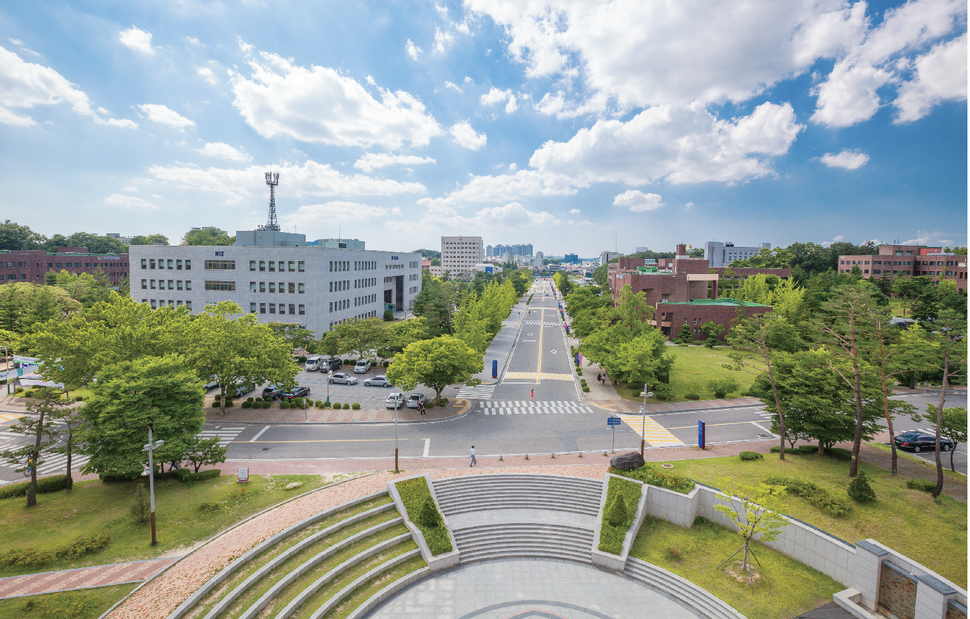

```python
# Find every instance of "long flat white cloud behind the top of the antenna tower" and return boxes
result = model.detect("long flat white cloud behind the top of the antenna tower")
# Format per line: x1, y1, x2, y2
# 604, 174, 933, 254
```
148, 161, 425, 204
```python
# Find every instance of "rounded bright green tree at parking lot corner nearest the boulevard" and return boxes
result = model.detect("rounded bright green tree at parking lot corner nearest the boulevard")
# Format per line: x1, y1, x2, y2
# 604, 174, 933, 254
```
387, 335, 485, 404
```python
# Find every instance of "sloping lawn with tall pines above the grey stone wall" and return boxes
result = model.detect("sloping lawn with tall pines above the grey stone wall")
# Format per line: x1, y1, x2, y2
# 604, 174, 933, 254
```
656, 454, 967, 588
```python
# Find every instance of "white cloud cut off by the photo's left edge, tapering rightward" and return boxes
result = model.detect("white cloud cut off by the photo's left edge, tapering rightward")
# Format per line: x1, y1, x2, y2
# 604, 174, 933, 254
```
0, 47, 138, 129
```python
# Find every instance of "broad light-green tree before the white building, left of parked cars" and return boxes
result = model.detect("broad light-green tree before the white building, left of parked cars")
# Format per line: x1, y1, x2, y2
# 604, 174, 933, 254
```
183, 301, 298, 412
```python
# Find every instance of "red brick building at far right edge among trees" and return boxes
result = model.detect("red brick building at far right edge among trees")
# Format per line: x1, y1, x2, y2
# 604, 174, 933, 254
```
839, 245, 967, 294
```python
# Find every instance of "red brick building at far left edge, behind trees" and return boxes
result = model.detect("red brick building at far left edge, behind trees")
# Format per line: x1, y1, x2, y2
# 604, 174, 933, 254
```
0, 247, 128, 286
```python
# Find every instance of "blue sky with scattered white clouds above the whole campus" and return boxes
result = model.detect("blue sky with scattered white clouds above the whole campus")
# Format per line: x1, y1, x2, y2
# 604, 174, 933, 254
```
0, 0, 968, 257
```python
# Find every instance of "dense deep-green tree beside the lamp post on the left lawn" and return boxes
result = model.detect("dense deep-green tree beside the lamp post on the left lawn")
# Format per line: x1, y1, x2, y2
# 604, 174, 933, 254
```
81, 355, 206, 476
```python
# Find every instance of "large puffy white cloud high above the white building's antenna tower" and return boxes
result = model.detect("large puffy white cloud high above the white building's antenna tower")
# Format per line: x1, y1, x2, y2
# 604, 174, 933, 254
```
230, 52, 443, 149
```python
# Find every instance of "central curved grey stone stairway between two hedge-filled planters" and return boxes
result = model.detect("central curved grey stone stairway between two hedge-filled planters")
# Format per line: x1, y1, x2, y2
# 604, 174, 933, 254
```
434, 474, 603, 564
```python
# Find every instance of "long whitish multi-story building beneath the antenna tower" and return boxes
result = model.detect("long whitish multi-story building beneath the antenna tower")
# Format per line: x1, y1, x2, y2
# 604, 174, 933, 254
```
129, 235, 421, 338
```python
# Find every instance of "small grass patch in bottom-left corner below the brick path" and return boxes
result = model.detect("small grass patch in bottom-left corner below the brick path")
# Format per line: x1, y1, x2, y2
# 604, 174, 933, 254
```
0, 583, 138, 619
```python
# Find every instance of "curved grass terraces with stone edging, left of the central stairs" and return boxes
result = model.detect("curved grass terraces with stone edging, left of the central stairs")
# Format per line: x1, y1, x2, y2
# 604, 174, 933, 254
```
169, 492, 427, 619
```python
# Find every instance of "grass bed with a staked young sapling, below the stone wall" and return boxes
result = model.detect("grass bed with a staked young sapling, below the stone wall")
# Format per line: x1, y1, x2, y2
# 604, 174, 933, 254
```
630, 518, 845, 619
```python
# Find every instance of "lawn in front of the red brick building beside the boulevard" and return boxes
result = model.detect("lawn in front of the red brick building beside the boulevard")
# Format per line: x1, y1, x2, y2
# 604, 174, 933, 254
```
612, 346, 755, 403
